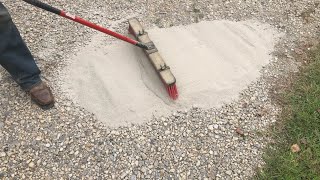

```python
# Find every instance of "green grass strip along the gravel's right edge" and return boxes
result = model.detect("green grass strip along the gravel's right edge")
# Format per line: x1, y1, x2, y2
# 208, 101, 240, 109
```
257, 47, 320, 180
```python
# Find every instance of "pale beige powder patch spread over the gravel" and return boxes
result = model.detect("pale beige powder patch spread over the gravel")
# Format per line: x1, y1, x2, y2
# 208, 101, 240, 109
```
64, 21, 279, 127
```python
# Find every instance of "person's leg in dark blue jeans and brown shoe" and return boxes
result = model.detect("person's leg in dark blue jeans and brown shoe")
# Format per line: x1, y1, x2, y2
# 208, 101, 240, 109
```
0, 2, 54, 109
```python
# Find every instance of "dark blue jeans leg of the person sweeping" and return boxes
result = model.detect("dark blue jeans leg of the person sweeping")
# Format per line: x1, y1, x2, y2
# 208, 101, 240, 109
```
0, 2, 41, 91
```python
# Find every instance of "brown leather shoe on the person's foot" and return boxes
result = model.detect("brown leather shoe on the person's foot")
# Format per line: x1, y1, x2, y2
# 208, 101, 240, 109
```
29, 82, 54, 110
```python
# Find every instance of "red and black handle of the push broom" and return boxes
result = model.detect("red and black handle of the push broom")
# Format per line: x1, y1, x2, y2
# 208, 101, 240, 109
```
23, 0, 149, 49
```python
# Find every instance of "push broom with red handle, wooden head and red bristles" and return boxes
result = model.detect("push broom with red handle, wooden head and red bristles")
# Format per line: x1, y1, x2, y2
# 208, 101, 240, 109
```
23, 0, 178, 100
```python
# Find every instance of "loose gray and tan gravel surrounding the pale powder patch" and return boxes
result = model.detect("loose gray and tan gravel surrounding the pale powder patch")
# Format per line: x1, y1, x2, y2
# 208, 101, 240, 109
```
0, 0, 320, 180
